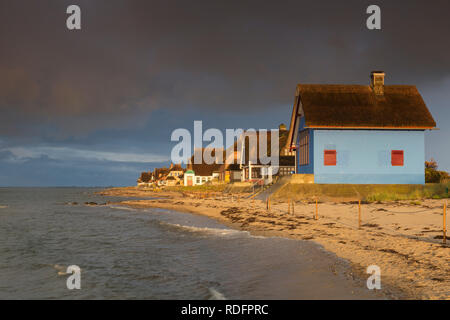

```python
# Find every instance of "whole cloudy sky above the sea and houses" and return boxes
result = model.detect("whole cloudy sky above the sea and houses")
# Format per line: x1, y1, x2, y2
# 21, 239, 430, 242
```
0, 0, 450, 186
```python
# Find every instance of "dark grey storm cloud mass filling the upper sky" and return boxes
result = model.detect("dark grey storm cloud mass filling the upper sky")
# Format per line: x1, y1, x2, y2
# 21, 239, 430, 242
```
0, 0, 450, 138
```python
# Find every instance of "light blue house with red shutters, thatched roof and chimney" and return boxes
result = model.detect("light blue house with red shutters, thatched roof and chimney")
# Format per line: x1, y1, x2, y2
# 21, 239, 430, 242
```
285, 71, 436, 184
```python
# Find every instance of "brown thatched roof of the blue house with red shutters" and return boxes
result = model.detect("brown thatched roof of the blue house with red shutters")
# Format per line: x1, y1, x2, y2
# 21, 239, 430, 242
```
297, 84, 436, 129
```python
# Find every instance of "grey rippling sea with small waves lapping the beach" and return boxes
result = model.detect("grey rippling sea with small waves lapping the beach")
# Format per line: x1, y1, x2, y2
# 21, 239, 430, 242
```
0, 188, 386, 300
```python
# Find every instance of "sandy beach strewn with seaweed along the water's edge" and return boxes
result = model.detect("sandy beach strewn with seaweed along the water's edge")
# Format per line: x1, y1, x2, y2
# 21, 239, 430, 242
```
100, 187, 450, 299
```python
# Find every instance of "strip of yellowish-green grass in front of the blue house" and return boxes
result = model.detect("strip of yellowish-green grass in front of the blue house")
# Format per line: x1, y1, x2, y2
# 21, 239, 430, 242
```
273, 183, 449, 202
